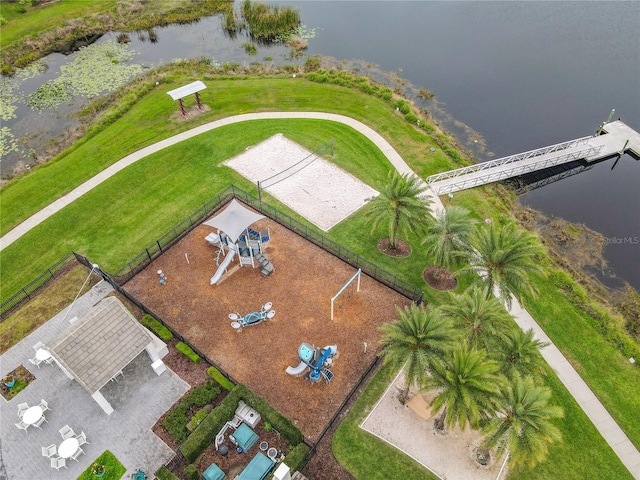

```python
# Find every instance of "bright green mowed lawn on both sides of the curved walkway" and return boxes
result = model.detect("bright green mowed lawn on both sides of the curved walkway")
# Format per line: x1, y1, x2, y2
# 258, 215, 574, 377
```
0, 75, 640, 478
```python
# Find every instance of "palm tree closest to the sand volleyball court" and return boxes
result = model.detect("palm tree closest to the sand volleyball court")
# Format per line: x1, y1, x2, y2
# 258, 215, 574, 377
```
365, 170, 431, 249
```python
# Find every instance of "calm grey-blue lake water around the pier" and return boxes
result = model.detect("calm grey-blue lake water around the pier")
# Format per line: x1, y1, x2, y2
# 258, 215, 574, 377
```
2, 1, 640, 289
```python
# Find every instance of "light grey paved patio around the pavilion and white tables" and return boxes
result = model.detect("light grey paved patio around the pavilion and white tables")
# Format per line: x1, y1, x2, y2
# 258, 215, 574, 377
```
0, 282, 189, 480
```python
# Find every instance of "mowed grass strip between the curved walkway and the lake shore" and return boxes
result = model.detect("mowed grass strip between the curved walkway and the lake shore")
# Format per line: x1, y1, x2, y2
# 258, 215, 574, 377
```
0, 77, 454, 235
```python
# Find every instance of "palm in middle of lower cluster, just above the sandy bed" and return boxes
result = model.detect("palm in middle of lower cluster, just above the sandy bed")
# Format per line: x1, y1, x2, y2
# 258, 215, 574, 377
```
425, 344, 504, 430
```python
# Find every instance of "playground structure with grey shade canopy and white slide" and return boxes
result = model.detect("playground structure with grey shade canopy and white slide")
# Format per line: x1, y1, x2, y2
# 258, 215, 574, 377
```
204, 200, 273, 285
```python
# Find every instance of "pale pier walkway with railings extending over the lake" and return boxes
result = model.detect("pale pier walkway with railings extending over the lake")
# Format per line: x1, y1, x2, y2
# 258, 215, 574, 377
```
427, 120, 640, 195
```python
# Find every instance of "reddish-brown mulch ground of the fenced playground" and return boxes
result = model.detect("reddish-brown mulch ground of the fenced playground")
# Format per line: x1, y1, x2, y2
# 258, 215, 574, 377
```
124, 215, 409, 450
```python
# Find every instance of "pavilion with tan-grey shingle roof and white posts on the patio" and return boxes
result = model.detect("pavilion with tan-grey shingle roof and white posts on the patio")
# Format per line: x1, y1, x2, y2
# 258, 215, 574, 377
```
51, 297, 160, 414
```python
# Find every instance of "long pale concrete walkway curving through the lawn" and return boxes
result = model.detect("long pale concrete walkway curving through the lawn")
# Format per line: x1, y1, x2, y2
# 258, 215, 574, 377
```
0, 112, 640, 480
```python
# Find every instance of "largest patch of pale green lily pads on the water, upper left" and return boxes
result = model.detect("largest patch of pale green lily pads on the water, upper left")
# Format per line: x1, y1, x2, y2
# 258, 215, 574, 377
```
28, 40, 143, 110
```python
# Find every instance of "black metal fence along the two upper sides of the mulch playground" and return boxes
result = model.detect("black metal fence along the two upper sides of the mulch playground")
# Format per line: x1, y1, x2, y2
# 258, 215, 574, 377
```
115, 185, 422, 302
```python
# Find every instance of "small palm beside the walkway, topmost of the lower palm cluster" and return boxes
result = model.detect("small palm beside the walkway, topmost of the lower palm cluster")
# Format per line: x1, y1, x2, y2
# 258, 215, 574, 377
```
441, 285, 511, 351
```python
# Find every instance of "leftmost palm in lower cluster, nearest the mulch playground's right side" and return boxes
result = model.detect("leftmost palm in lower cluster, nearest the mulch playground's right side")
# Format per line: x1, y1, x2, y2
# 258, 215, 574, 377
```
379, 304, 457, 402
